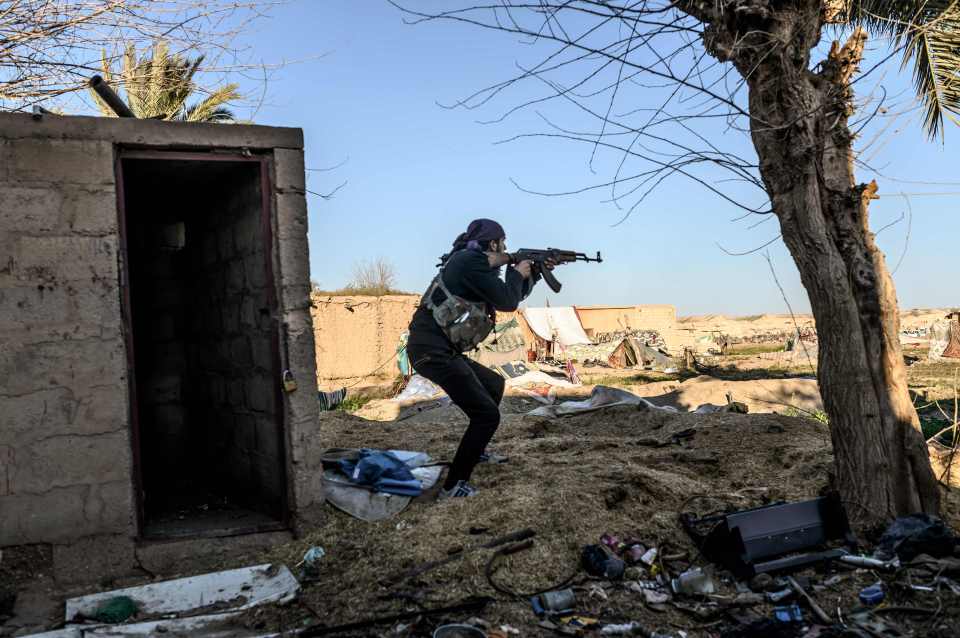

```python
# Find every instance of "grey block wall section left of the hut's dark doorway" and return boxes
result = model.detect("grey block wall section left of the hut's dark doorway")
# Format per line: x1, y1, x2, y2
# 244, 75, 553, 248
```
0, 135, 133, 546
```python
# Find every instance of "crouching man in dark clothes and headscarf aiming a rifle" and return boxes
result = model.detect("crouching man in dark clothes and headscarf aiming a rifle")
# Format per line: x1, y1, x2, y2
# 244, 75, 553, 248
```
407, 219, 600, 499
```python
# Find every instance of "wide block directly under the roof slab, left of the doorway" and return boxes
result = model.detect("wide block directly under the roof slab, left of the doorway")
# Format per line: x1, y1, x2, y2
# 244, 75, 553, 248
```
7, 139, 115, 186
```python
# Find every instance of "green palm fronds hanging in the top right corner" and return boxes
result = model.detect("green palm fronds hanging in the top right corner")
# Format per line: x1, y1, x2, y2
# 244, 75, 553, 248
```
849, 0, 960, 139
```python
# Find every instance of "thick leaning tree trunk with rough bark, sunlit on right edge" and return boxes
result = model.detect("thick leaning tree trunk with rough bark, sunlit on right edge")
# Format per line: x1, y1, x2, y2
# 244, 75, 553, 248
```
738, 26, 939, 523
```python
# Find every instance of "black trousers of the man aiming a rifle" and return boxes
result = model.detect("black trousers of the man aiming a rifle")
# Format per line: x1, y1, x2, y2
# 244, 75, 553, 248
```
407, 344, 504, 489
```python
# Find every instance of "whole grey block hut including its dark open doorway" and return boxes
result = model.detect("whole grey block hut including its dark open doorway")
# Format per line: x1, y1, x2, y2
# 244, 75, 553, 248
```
0, 113, 323, 584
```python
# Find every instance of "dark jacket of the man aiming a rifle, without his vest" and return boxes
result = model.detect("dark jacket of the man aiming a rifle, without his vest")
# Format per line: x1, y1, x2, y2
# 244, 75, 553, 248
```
407, 250, 536, 350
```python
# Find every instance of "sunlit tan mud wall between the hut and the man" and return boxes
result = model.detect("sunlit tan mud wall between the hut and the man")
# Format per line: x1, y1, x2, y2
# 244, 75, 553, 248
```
311, 294, 420, 390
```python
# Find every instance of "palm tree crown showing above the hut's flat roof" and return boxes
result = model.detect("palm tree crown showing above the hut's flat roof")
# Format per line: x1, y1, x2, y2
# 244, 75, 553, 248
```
93, 40, 240, 122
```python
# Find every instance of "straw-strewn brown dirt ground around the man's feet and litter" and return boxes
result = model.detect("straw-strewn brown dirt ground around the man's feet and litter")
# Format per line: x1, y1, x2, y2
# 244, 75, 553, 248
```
244, 399, 960, 636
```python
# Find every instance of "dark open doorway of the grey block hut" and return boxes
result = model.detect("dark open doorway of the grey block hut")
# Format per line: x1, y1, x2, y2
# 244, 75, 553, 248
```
118, 151, 287, 538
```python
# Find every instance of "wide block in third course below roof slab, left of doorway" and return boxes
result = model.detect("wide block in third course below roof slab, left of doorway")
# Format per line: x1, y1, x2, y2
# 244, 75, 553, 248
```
14, 236, 118, 284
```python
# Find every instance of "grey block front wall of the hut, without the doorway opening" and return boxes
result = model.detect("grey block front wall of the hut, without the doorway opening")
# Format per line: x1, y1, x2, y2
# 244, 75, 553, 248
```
0, 113, 323, 556
